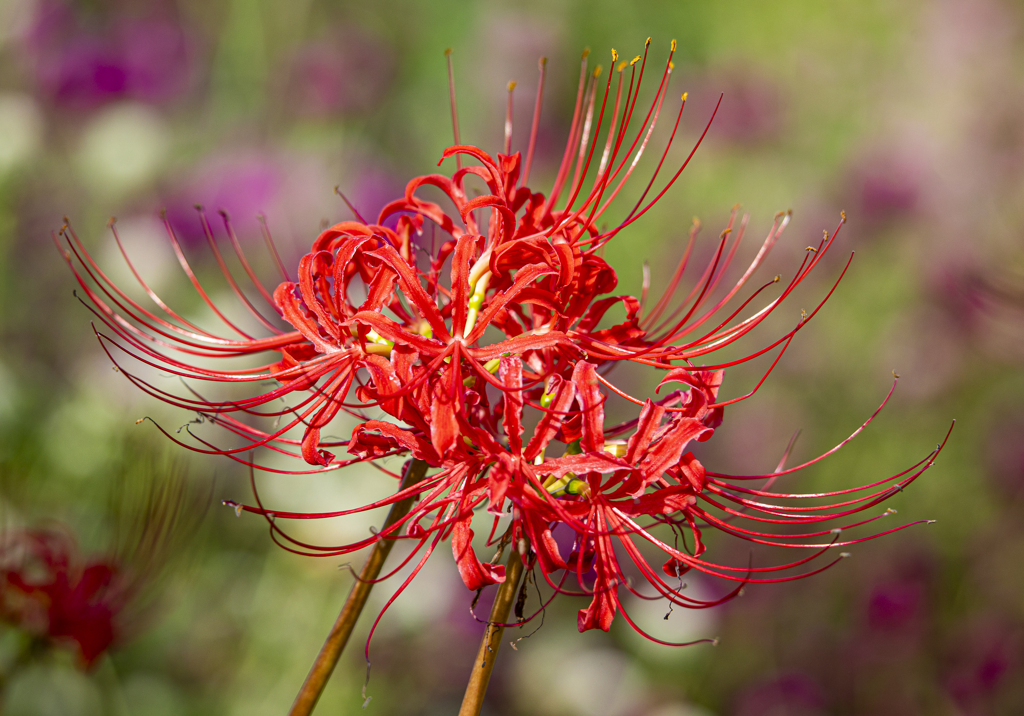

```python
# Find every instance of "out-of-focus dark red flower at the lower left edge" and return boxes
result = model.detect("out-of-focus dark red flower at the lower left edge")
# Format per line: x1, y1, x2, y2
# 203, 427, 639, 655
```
0, 530, 127, 667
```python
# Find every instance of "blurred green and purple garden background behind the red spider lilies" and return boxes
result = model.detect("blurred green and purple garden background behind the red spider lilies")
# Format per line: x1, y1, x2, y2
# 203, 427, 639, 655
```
0, 0, 1024, 716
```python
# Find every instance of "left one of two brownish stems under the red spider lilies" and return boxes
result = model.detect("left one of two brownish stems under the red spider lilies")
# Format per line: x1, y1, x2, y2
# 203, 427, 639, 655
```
288, 459, 427, 716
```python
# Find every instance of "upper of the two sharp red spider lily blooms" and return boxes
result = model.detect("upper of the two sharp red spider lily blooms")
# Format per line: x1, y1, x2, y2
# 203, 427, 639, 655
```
62, 41, 819, 468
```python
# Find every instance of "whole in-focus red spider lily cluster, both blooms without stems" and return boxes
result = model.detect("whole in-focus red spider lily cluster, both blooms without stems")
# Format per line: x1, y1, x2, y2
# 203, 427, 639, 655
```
61, 40, 935, 640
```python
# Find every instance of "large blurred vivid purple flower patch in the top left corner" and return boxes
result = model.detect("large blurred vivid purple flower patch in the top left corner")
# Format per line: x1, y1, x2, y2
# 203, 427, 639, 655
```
23, 0, 190, 109
